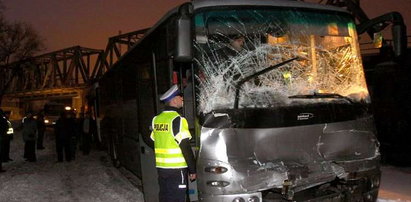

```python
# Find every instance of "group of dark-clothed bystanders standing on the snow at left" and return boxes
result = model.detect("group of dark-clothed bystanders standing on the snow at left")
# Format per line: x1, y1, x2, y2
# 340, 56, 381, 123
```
0, 109, 96, 172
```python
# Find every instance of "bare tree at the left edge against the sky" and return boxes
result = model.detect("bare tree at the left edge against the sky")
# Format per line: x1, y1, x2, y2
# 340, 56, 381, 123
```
0, 3, 43, 104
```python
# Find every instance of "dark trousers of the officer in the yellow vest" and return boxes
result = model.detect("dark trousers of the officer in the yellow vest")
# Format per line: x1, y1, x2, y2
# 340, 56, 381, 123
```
157, 168, 188, 202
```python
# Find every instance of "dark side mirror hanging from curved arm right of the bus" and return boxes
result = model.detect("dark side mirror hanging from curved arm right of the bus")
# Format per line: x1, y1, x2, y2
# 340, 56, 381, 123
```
391, 24, 407, 59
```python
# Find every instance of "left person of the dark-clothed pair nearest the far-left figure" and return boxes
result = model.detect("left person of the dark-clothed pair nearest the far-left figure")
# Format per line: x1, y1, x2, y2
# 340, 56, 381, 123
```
22, 112, 37, 162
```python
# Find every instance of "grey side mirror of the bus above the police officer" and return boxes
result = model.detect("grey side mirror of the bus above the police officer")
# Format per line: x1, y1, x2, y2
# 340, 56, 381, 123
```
174, 3, 193, 62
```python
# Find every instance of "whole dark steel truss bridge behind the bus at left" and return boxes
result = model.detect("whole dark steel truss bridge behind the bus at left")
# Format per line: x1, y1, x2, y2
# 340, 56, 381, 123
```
0, 29, 148, 100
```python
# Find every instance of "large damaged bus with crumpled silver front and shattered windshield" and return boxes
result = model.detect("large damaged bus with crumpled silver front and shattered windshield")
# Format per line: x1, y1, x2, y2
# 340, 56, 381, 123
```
95, 0, 380, 202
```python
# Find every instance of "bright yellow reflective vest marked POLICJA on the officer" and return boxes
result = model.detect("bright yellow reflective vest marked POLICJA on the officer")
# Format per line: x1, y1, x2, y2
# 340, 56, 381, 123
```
152, 111, 187, 168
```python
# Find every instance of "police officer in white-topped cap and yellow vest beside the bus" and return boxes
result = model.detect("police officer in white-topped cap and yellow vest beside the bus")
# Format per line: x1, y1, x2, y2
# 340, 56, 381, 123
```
151, 85, 196, 202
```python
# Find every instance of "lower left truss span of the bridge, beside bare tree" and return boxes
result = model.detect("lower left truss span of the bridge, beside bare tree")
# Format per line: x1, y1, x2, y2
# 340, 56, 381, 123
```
6, 46, 103, 97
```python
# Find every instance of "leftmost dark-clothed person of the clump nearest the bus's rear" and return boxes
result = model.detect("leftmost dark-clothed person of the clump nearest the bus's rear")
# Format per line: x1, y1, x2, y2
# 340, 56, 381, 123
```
54, 111, 76, 162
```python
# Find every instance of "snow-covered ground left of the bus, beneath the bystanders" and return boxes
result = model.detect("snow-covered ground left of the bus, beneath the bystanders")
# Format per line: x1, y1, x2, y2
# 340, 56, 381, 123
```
0, 127, 144, 202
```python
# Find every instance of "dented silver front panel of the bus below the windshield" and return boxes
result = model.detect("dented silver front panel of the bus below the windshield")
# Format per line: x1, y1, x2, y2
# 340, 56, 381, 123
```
198, 117, 379, 198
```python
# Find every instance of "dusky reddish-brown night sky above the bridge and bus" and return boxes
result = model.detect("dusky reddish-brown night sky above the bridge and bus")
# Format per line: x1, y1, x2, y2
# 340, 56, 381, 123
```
3, 0, 411, 52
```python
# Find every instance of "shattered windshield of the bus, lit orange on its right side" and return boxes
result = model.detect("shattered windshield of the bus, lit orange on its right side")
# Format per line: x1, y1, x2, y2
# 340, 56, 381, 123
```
195, 8, 369, 113
